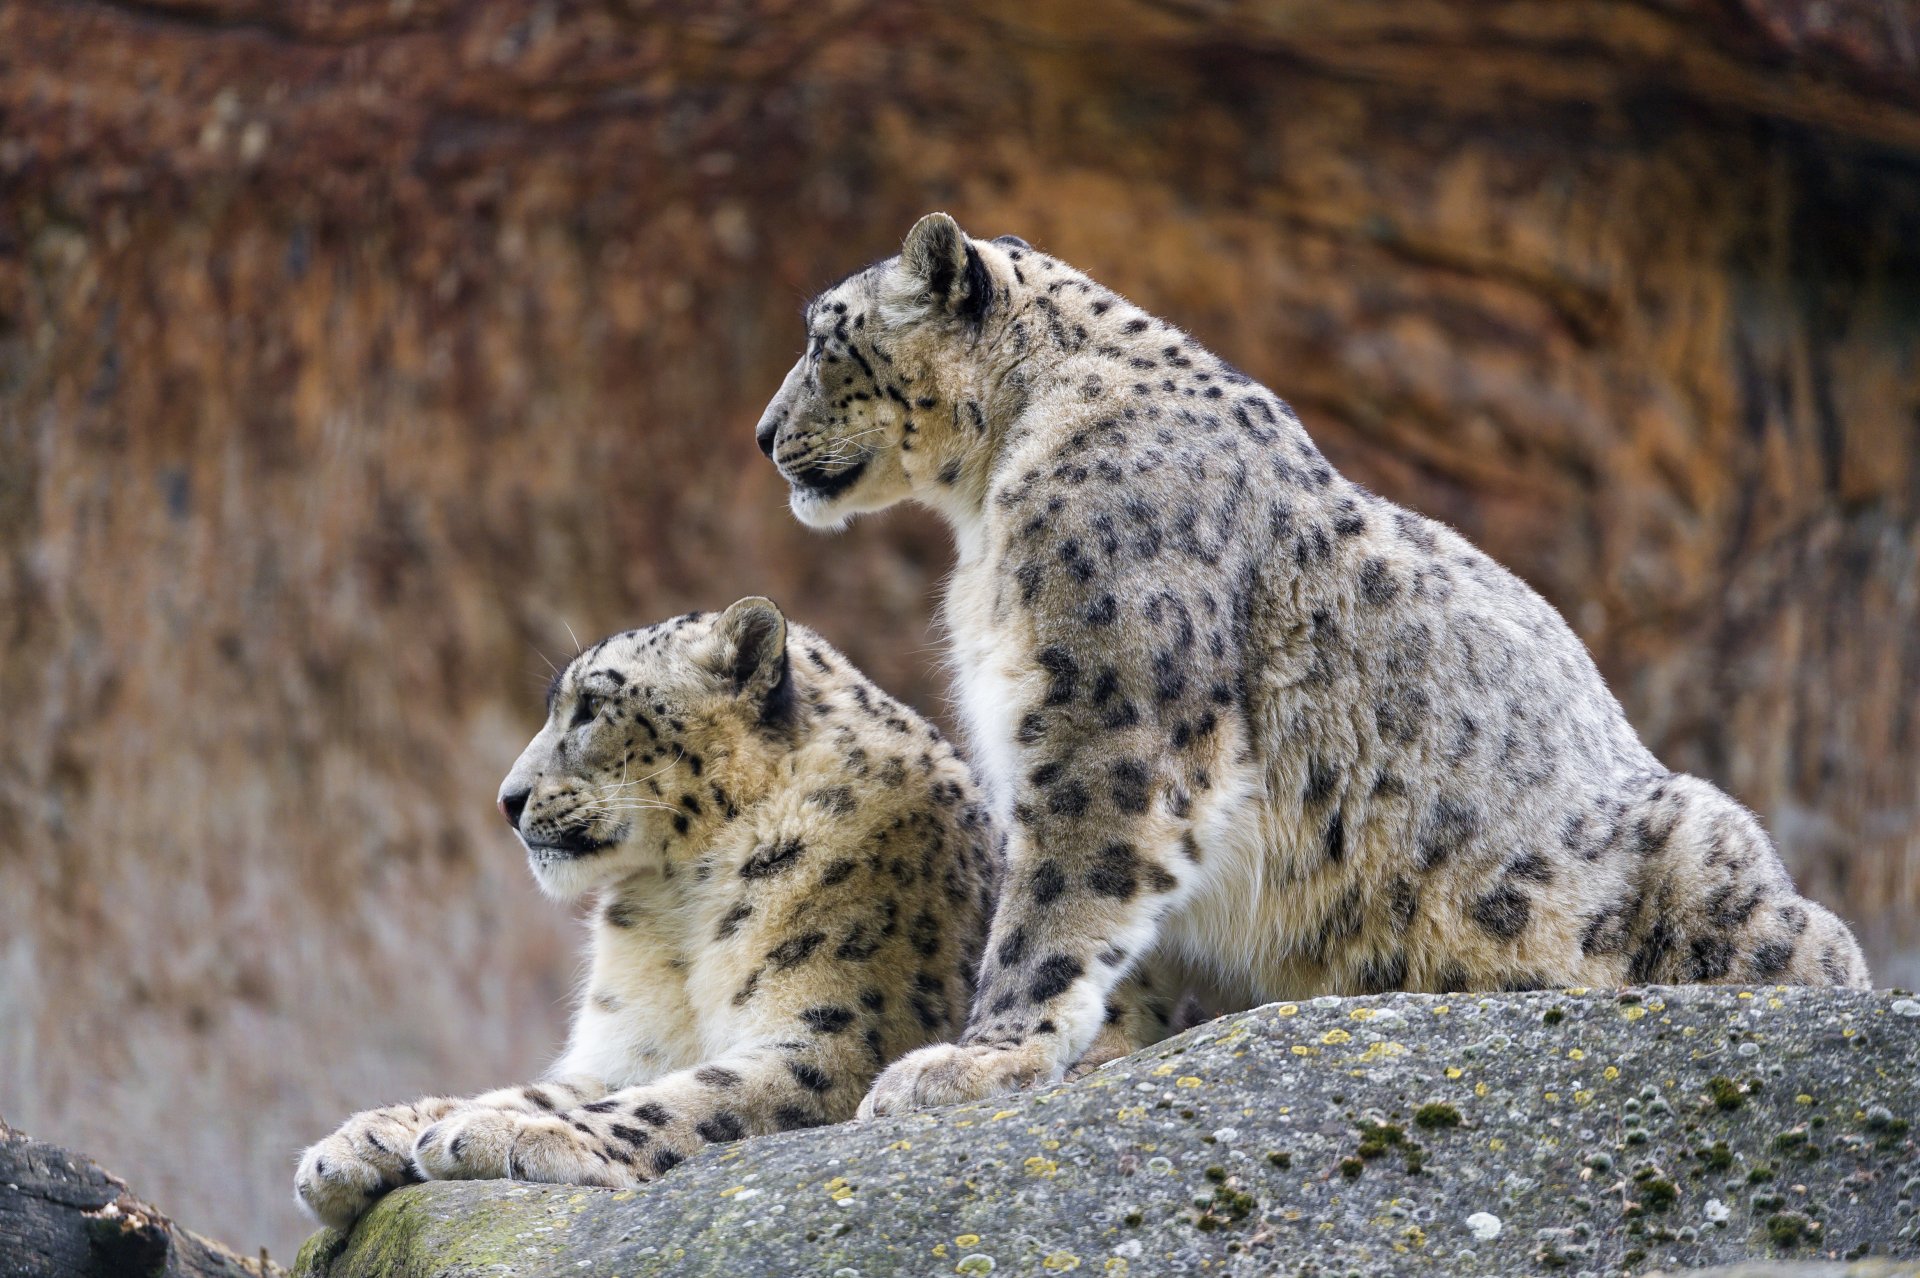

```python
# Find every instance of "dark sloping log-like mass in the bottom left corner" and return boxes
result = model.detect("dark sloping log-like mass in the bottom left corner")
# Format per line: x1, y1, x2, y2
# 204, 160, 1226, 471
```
0, 1121, 284, 1278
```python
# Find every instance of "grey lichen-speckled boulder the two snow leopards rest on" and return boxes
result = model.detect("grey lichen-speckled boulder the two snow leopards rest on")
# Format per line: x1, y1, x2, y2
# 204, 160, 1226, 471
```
296, 988, 1920, 1278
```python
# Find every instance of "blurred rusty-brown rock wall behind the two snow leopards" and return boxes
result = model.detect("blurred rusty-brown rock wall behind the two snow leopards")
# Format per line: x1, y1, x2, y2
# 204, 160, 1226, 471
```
0, 0, 1920, 1257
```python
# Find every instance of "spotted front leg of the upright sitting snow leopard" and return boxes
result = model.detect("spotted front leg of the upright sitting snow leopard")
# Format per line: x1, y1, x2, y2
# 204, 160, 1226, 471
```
860, 602, 1238, 1117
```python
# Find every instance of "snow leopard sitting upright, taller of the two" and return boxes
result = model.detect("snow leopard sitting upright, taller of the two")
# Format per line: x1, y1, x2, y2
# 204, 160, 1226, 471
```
758, 213, 1866, 1113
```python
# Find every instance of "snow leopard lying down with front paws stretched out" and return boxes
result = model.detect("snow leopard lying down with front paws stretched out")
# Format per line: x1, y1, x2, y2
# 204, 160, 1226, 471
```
296, 599, 1000, 1226
